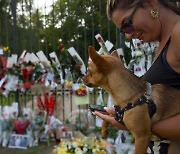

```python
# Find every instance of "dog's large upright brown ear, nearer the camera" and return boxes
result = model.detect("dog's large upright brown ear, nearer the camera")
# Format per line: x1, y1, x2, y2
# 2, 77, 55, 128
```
88, 46, 107, 71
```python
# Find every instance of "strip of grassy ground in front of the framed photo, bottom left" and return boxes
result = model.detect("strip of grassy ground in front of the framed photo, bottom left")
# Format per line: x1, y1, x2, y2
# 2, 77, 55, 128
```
0, 142, 55, 154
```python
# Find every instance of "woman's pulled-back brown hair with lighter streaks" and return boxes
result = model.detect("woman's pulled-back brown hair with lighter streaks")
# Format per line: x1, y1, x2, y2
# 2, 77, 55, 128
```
107, 0, 180, 19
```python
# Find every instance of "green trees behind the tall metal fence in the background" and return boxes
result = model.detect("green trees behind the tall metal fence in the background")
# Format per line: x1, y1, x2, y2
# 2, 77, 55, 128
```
0, 0, 117, 68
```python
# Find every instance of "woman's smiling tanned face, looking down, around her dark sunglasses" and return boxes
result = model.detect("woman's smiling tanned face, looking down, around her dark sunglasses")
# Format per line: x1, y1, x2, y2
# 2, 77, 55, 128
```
112, 6, 161, 42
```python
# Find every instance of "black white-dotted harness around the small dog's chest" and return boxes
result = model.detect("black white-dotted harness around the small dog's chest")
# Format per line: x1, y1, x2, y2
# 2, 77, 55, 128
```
114, 83, 156, 123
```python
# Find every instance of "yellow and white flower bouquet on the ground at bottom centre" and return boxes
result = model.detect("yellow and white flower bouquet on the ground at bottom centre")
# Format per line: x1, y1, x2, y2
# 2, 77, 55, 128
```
52, 137, 107, 154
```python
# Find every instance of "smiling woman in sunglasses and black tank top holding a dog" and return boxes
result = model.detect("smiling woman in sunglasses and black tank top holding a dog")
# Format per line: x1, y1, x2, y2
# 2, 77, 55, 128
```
94, 0, 180, 154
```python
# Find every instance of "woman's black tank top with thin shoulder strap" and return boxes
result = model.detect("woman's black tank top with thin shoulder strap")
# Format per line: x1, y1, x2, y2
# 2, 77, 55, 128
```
142, 38, 180, 90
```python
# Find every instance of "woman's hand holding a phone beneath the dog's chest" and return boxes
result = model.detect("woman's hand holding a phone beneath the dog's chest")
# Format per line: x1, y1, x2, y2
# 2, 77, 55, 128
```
93, 107, 127, 130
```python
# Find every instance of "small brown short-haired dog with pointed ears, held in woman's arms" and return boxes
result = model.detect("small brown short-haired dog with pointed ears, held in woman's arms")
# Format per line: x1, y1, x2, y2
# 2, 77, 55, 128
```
83, 46, 180, 154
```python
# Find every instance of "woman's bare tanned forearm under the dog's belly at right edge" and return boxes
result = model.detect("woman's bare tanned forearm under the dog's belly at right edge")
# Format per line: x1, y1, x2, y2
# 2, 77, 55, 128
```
152, 114, 180, 140
